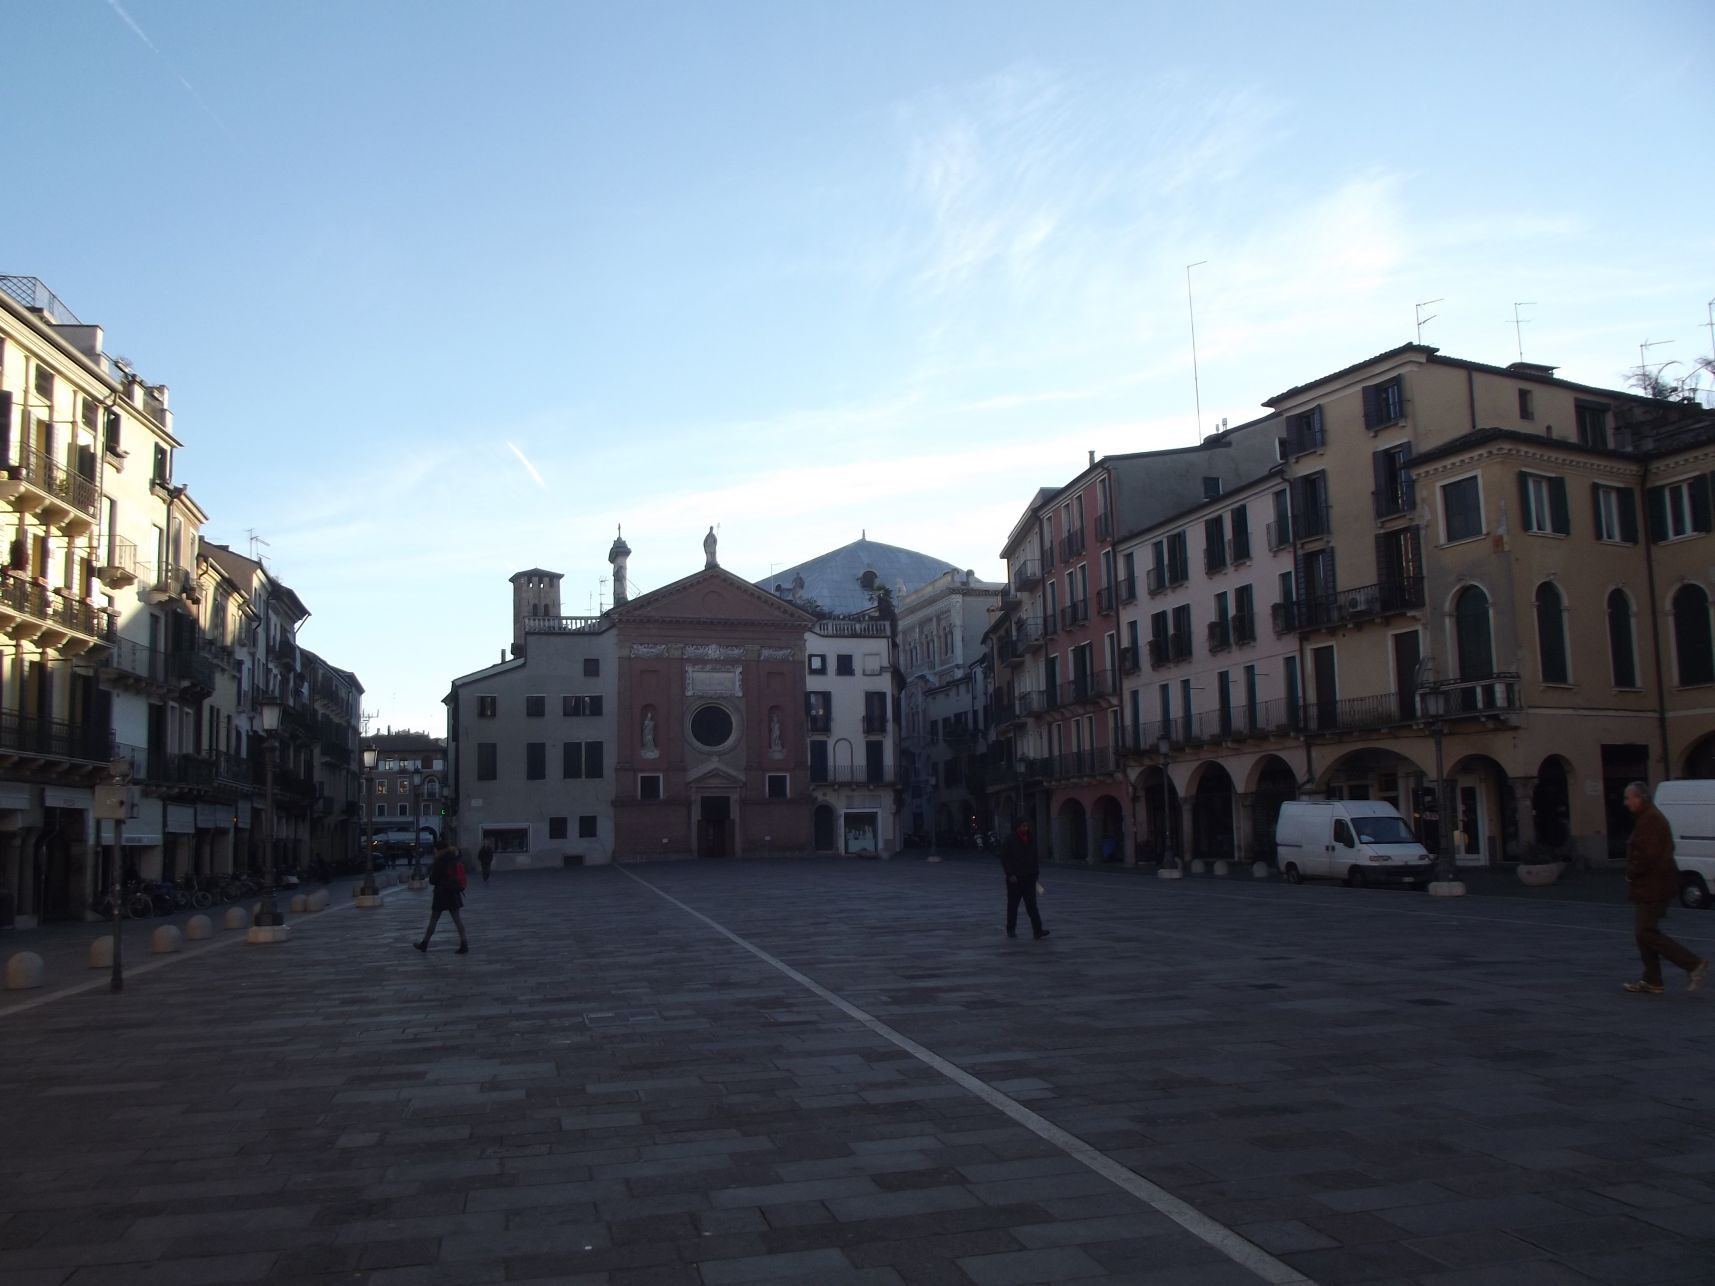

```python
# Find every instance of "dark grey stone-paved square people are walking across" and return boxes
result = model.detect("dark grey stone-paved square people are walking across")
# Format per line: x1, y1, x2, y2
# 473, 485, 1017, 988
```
0, 859, 1715, 1286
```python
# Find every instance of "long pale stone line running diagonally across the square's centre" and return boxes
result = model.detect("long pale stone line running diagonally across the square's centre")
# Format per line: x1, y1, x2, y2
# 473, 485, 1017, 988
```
614, 866, 1315, 1286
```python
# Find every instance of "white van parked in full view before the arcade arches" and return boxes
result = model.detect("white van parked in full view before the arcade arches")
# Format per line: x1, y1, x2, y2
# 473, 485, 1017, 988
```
1274, 799, 1435, 888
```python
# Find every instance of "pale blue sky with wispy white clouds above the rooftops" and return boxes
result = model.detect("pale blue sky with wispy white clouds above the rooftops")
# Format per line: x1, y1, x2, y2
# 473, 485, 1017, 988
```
0, 0, 1715, 732
